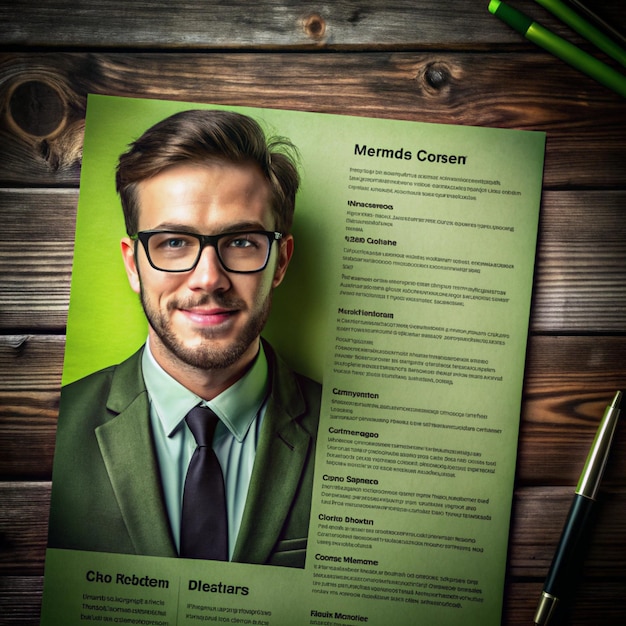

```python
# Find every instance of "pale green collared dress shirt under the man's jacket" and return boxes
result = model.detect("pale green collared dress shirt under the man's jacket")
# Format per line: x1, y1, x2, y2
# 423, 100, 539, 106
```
142, 342, 268, 559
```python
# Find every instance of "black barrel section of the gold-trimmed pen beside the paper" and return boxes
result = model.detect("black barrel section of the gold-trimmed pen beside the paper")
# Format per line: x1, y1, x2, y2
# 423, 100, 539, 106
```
543, 494, 595, 598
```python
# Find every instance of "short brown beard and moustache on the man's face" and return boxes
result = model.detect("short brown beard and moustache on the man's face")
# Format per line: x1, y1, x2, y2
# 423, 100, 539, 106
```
140, 288, 272, 370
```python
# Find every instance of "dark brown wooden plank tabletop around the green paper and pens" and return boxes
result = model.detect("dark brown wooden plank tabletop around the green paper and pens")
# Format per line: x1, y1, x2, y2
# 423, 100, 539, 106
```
0, 0, 626, 626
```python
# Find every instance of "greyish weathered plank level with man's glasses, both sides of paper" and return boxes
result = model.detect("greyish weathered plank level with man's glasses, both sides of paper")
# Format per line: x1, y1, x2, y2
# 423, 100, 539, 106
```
0, 189, 626, 333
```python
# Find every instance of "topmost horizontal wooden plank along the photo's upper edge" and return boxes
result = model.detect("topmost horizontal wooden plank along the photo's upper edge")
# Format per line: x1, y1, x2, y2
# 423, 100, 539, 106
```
6, 0, 624, 49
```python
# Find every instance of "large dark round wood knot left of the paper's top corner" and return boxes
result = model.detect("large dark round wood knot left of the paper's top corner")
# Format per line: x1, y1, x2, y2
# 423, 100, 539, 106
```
7, 80, 67, 139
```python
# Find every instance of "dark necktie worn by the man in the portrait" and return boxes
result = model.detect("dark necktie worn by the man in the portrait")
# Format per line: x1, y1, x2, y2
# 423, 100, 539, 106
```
180, 406, 228, 561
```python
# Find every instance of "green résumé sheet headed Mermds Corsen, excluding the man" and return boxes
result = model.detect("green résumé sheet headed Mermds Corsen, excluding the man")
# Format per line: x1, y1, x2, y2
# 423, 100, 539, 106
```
41, 96, 545, 626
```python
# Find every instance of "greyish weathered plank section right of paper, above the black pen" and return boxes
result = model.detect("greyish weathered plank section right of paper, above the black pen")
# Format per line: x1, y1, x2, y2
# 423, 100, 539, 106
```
531, 191, 626, 333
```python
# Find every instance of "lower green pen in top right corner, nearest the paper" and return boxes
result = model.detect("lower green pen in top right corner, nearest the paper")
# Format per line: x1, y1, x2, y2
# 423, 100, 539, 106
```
489, 0, 626, 98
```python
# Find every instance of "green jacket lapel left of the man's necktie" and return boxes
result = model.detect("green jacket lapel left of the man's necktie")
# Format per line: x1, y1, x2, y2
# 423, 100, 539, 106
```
96, 351, 176, 557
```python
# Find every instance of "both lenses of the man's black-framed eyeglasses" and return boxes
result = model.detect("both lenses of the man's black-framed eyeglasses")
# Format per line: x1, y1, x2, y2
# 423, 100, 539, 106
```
148, 232, 271, 272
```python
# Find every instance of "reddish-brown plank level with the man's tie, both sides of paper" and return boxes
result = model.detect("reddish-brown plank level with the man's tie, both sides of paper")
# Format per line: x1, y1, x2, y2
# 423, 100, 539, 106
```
0, 335, 626, 480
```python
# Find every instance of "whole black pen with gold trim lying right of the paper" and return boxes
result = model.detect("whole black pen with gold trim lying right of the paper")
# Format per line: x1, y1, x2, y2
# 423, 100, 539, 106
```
535, 391, 622, 626
